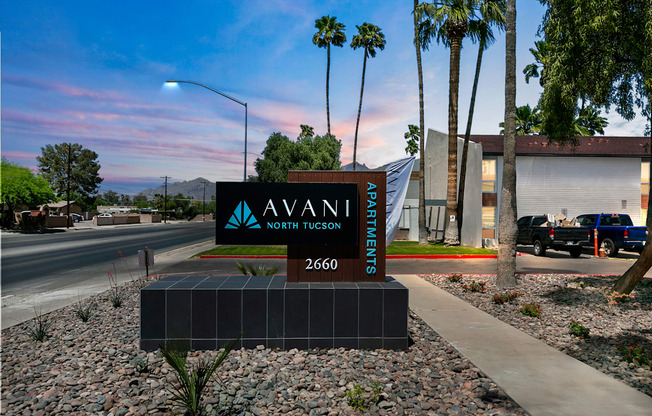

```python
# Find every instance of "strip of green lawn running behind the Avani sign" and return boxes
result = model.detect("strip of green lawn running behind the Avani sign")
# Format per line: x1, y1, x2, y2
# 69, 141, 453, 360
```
195, 241, 497, 257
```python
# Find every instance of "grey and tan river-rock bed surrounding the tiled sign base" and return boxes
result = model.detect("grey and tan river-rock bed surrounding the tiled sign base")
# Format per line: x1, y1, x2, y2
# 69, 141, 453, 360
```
1, 278, 528, 416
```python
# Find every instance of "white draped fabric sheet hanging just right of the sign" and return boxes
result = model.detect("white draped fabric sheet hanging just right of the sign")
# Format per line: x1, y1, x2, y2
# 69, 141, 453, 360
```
385, 156, 415, 246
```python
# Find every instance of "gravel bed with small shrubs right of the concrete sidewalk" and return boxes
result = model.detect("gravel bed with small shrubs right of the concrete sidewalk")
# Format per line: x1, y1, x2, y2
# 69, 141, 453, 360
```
422, 274, 652, 396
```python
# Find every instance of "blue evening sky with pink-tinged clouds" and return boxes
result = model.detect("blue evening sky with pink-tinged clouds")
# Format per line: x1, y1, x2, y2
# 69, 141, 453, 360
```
0, 0, 645, 194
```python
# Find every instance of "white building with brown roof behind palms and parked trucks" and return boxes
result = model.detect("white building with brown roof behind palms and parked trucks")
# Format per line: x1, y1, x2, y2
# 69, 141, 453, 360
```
401, 130, 650, 247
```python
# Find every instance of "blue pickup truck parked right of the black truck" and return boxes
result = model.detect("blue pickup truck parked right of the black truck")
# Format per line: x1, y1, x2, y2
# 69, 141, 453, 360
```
577, 214, 647, 257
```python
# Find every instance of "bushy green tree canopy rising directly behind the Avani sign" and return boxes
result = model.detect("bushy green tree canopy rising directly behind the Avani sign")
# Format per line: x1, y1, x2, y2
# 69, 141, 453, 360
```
255, 126, 342, 182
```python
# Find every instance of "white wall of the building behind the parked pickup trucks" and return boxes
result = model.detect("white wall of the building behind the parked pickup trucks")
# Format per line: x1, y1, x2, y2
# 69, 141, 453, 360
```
496, 156, 641, 224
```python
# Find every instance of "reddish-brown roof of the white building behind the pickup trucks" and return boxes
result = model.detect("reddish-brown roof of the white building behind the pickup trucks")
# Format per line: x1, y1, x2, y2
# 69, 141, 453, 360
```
470, 134, 650, 157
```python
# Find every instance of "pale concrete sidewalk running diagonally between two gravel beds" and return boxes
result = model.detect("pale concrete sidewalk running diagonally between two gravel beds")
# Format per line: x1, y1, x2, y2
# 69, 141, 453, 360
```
393, 275, 652, 416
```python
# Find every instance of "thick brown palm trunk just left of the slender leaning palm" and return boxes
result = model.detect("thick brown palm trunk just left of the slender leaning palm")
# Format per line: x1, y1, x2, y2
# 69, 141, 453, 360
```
444, 37, 462, 246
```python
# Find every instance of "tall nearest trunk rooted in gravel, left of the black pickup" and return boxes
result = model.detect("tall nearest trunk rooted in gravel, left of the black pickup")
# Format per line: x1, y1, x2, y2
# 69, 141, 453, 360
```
496, 0, 518, 287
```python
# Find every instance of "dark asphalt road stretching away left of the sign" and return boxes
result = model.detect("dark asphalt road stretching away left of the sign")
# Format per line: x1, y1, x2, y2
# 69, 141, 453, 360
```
1, 222, 215, 297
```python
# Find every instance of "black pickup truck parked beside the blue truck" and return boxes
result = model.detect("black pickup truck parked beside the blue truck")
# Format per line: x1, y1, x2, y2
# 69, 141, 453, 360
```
516, 215, 591, 257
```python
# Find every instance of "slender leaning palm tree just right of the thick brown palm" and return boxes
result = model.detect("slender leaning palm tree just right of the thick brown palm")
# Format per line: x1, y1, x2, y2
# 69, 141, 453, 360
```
457, 0, 505, 236
